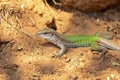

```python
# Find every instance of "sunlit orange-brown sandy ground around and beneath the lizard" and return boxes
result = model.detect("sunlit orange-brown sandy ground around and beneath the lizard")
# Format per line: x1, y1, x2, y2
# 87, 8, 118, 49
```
0, 0, 120, 80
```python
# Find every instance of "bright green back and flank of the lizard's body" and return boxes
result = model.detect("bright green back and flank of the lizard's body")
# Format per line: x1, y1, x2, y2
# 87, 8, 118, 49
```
64, 35, 99, 47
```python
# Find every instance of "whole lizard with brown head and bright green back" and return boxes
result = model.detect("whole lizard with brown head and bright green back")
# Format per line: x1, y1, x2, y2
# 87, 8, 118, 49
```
36, 28, 120, 57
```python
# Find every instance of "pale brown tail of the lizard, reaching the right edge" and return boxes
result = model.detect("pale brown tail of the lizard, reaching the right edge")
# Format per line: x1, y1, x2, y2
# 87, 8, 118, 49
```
99, 38, 120, 51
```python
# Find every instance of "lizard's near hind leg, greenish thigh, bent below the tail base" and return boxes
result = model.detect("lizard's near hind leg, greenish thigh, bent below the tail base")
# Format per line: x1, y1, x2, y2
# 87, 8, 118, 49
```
91, 43, 108, 58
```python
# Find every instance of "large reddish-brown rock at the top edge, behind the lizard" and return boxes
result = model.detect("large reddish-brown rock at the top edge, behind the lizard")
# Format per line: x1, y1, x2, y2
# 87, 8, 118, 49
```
61, 0, 119, 12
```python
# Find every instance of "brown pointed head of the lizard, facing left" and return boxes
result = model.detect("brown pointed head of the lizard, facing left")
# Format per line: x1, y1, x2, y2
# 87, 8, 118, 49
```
36, 28, 57, 39
